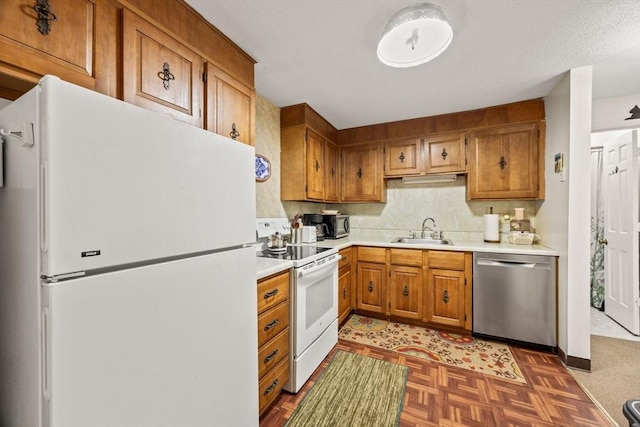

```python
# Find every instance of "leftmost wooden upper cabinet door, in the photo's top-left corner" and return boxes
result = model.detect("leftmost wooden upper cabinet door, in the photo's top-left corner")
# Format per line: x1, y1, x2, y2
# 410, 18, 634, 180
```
0, 0, 96, 89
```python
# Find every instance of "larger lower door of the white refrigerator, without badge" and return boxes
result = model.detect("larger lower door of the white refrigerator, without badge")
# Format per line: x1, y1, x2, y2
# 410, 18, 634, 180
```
43, 248, 258, 427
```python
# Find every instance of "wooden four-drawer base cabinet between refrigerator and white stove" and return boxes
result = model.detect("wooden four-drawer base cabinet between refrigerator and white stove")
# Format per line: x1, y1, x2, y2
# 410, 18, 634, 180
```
258, 271, 290, 415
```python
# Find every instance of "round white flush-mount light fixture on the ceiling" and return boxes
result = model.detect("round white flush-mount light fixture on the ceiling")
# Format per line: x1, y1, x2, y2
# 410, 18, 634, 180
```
378, 3, 453, 68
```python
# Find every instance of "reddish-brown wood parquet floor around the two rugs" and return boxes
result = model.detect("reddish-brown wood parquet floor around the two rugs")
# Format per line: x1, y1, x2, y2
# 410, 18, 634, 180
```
260, 340, 612, 427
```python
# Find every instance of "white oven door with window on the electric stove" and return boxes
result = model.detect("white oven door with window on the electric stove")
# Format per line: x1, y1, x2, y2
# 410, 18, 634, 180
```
292, 258, 339, 356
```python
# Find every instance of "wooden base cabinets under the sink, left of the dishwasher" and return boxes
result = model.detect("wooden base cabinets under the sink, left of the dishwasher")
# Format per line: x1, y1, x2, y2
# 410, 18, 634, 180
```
355, 247, 472, 331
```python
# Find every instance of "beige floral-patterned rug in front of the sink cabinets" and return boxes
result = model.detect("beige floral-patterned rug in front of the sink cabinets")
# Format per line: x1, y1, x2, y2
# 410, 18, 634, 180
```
338, 314, 527, 383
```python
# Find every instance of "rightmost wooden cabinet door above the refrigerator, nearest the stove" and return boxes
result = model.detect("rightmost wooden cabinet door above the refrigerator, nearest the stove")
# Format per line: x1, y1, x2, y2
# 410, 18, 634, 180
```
204, 63, 256, 145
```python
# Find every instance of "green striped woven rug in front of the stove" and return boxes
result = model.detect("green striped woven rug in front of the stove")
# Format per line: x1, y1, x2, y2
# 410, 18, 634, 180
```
286, 351, 409, 427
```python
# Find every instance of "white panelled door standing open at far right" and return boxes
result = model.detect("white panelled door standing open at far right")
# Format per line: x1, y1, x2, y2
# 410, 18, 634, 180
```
603, 130, 640, 335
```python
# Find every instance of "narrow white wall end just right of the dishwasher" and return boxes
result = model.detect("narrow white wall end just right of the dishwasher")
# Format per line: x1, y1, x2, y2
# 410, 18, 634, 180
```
536, 66, 592, 359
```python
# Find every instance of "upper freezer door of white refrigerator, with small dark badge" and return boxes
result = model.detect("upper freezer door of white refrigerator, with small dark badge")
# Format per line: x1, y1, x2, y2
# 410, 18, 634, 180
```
34, 77, 255, 276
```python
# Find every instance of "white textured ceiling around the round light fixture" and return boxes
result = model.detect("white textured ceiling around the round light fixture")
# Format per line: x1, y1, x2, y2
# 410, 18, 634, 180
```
186, 0, 640, 129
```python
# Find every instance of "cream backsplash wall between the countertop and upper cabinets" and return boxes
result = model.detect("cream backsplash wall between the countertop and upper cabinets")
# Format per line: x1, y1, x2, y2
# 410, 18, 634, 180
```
256, 95, 542, 240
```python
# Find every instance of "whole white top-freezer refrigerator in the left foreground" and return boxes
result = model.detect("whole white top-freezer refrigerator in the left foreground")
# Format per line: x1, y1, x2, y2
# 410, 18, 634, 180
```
0, 76, 258, 427
